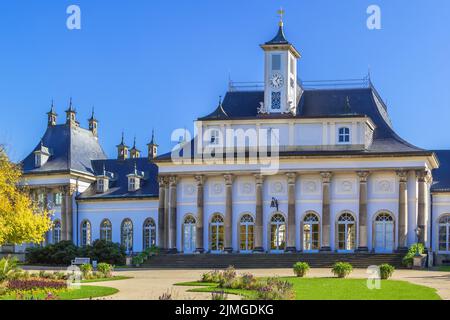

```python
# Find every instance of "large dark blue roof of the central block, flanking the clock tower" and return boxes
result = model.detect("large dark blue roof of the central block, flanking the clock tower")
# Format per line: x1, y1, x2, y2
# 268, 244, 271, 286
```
195, 86, 425, 154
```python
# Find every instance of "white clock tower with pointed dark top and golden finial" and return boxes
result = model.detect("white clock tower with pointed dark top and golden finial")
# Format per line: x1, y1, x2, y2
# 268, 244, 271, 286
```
260, 10, 300, 114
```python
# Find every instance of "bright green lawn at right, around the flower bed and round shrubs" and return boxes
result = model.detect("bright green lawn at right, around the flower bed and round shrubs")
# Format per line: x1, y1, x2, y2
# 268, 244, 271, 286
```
178, 277, 441, 300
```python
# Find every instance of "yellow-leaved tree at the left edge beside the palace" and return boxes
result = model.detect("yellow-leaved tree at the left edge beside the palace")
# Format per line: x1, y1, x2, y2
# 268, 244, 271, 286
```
0, 146, 52, 245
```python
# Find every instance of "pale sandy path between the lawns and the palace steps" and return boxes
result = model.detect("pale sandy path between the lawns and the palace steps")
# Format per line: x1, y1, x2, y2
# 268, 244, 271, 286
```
22, 268, 450, 300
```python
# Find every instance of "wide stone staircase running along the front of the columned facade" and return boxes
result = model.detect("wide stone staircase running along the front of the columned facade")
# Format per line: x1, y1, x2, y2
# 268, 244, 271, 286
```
142, 253, 403, 269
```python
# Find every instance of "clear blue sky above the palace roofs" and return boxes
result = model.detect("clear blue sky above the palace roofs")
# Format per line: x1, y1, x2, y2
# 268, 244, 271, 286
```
0, 0, 450, 161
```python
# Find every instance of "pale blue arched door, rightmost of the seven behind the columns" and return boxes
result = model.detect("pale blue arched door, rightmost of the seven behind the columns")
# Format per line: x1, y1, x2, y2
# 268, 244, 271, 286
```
374, 212, 394, 252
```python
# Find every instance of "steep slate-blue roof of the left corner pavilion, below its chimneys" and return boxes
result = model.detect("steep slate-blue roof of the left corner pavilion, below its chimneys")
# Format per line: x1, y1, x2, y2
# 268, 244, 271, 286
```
21, 124, 106, 175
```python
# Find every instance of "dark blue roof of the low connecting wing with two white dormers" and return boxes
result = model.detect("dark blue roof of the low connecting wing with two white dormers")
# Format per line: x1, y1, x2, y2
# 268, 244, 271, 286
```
77, 158, 159, 200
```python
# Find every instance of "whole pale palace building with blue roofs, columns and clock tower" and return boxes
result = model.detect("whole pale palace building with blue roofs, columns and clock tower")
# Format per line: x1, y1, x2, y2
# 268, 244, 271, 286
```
5, 21, 450, 263
